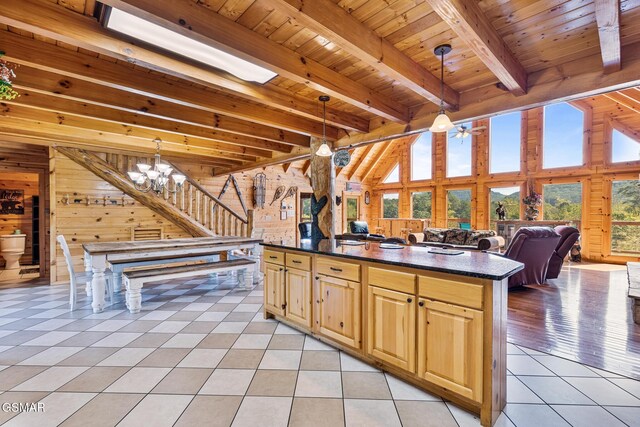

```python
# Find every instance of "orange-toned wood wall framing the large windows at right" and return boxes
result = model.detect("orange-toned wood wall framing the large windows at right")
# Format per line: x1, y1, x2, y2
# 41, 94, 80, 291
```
366, 96, 640, 263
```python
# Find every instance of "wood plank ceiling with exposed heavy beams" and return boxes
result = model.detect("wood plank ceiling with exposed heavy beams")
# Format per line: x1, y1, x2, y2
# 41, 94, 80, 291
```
0, 0, 640, 177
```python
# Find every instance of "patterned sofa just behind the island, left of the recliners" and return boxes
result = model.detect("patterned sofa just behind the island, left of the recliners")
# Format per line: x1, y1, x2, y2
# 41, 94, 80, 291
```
409, 227, 504, 251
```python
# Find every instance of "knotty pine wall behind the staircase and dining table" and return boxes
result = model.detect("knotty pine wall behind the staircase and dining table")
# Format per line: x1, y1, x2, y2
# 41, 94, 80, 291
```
51, 151, 368, 282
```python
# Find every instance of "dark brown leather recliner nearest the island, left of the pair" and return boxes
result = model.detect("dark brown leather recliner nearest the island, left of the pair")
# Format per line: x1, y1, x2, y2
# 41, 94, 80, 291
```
503, 227, 560, 289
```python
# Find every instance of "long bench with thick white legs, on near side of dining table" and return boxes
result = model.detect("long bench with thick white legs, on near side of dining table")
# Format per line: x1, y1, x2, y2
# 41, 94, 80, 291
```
124, 259, 255, 313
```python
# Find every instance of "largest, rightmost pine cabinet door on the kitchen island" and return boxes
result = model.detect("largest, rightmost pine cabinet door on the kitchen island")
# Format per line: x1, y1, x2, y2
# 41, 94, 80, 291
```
418, 298, 482, 403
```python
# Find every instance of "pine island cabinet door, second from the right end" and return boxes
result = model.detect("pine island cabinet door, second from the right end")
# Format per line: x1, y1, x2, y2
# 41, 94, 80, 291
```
367, 286, 416, 372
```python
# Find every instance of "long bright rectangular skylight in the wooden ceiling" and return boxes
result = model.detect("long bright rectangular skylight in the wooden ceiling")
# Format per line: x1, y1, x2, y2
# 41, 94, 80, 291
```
105, 8, 277, 84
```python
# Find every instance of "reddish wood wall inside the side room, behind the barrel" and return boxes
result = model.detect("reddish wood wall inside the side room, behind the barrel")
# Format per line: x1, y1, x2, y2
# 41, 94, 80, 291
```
0, 172, 40, 267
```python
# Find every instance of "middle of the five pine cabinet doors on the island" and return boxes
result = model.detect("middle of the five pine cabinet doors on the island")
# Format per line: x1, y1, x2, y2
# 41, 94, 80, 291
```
318, 275, 361, 348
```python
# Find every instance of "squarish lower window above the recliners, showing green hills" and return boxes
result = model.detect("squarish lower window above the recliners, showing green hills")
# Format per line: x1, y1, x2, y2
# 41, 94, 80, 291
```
542, 182, 582, 221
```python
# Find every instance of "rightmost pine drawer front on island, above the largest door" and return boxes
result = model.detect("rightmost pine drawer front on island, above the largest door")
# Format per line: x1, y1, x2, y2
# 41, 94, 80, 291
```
418, 276, 483, 309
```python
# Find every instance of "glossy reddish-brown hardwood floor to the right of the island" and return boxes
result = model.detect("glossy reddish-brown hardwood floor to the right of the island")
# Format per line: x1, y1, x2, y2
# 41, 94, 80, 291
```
507, 264, 640, 379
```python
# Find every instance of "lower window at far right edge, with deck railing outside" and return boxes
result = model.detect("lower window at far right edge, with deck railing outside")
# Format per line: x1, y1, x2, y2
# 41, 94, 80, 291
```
611, 179, 640, 255
